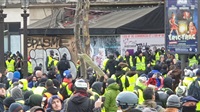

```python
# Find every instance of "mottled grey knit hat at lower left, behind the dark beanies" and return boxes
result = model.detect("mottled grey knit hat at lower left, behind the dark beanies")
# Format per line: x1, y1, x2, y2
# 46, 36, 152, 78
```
11, 87, 24, 100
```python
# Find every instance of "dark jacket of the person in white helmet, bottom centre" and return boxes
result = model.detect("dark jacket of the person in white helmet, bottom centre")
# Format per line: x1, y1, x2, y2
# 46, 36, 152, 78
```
65, 90, 94, 112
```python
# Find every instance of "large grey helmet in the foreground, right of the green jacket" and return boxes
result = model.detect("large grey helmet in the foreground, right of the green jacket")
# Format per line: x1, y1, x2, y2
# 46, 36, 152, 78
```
116, 91, 138, 110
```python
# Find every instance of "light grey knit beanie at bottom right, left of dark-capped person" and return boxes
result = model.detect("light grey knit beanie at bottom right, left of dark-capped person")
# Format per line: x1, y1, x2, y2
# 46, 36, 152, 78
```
167, 95, 180, 108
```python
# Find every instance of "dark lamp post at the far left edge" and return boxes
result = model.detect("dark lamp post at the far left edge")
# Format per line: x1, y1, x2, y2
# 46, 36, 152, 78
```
0, 0, 7, 73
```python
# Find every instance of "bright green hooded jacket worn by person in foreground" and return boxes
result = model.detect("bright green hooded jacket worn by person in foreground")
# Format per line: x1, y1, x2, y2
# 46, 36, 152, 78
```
104, 83, 120, 112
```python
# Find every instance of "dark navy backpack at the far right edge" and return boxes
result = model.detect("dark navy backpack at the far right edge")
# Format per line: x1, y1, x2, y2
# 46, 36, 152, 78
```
188, 80, 200, 100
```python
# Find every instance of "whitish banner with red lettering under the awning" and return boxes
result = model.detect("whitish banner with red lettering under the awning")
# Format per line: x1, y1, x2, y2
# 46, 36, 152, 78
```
120, 34, 165, 56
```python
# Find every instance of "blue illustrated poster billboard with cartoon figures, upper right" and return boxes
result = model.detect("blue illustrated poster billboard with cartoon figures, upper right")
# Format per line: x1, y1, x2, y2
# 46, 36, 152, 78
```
165, 0, 199, 54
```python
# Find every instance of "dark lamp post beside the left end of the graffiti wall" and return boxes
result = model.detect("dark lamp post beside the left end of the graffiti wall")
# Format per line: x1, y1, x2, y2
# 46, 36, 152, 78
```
21, 0, 29, 76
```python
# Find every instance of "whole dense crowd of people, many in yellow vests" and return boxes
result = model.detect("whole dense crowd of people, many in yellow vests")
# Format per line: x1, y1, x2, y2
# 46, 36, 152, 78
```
0, 46, 200, 112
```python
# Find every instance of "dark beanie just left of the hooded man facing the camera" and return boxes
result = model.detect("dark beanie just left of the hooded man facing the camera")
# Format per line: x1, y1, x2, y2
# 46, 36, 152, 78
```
28, 94, 42, 107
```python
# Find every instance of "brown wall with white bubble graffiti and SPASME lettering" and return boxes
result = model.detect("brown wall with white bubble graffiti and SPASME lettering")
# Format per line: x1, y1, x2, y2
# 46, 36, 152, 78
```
28, 37, 76, 78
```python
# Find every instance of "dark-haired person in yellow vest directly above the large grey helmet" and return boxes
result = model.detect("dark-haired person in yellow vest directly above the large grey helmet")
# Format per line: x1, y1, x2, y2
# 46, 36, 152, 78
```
126, 67, 138, 92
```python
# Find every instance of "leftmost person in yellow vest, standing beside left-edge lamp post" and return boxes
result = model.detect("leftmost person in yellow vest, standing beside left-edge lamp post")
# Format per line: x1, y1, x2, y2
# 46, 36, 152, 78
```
6, 57, 15, 72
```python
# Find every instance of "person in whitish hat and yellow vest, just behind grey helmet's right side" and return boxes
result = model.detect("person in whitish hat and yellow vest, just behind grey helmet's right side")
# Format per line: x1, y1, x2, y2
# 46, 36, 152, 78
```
134, 77, 147, 104
